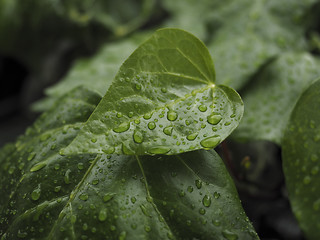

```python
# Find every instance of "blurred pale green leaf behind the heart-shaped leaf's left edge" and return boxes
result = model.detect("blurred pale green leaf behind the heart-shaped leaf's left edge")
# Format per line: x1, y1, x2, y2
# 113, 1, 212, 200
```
33, 32, 150, 111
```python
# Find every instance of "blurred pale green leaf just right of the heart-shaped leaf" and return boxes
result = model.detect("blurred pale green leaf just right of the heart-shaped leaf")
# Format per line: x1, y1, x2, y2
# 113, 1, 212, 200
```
233, 53, 320, 144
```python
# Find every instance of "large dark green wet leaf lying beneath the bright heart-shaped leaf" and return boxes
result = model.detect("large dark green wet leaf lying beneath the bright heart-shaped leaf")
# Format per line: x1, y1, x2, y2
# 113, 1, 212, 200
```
0, 88, 258, 240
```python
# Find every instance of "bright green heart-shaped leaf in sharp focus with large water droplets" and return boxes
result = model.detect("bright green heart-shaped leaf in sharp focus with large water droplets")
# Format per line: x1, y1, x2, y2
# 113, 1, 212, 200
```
61, 29, 243, 155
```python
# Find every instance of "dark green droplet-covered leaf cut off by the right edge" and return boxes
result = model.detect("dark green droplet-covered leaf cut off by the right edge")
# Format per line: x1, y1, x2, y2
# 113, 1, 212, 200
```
282, 80, 320, 240
